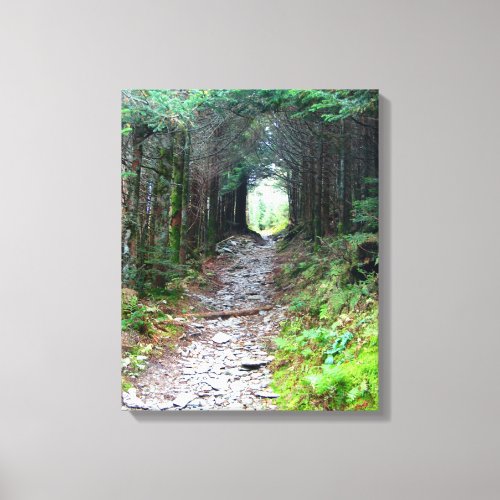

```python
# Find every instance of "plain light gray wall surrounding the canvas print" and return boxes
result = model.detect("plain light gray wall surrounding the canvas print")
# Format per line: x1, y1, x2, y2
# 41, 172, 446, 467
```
0, 0, 500, 500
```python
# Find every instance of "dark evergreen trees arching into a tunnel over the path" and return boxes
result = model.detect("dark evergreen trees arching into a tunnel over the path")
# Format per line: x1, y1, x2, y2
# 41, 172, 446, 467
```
122, 90, 378, 292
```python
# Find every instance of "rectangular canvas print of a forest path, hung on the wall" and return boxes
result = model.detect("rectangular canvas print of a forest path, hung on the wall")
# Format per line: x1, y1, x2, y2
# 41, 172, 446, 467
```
122, 89, 379, 412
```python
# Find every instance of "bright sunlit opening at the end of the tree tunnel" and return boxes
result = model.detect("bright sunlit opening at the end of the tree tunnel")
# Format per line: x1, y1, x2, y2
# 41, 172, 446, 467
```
248, 179, 288, 236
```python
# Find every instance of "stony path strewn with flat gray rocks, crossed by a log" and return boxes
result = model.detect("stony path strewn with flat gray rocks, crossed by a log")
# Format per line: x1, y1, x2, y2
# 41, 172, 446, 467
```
123, 236, 283, 410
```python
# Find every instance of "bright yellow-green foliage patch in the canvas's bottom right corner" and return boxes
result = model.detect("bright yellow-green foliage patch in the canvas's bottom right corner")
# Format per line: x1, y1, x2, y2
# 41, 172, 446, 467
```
273, 307, 378, 410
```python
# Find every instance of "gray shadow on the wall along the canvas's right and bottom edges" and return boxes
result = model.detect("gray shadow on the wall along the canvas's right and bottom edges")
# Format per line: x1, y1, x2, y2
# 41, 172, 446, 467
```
127, 95, 392, 424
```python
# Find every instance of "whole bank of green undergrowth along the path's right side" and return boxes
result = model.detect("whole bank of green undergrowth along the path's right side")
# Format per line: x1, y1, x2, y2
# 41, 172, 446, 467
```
273, 233, 378, 410
